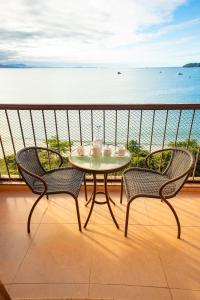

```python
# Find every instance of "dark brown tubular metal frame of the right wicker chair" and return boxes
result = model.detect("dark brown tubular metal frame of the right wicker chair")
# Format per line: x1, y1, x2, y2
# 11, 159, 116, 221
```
120, 147, 194, 239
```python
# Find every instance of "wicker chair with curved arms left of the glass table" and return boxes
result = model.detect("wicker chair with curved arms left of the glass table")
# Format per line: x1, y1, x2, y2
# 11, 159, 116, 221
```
16, 147, 87, 233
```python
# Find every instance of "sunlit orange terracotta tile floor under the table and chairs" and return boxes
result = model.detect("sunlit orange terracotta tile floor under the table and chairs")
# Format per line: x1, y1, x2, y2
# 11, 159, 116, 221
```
0, 190, 200, 300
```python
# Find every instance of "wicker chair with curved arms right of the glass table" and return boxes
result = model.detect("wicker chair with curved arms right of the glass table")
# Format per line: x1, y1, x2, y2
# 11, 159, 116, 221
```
120, 148, 194, 239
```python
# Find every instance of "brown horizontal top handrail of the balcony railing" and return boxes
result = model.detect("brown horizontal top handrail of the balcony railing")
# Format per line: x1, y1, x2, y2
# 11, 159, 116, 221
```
0, 103, 200, 110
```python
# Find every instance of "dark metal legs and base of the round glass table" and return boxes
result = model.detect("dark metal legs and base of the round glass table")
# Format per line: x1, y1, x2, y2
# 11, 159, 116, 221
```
84, 173, 119, 229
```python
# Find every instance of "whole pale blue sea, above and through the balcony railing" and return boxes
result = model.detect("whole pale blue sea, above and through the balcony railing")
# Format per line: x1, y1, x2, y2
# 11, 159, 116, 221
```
0, 67, 200, 157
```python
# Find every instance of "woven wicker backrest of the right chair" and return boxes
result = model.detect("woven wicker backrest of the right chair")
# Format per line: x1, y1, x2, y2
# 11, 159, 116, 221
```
164, 148, 194, 182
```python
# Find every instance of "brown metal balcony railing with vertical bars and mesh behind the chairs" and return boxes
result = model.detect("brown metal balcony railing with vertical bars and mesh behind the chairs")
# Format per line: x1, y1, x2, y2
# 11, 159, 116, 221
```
0, 104, 200, 182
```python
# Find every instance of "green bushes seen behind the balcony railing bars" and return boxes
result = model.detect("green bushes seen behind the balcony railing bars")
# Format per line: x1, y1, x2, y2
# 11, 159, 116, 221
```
0, 136, 200, 176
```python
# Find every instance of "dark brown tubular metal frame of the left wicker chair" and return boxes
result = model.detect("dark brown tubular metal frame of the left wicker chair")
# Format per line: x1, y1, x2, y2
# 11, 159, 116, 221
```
16, 147, 87, 233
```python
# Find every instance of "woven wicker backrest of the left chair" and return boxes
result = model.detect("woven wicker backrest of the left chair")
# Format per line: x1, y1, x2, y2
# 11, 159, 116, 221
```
16, 147, 45, 188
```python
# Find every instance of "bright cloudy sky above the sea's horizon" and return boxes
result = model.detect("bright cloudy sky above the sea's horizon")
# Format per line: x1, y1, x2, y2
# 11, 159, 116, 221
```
0, 0, 200, 67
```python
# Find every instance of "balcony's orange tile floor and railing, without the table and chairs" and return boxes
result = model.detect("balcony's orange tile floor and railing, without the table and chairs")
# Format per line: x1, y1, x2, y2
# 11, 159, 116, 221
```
0, 104, 200, 300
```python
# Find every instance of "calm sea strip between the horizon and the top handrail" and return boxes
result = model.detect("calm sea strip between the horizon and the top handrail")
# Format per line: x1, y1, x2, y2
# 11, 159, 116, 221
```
0, 67, 200, 104
